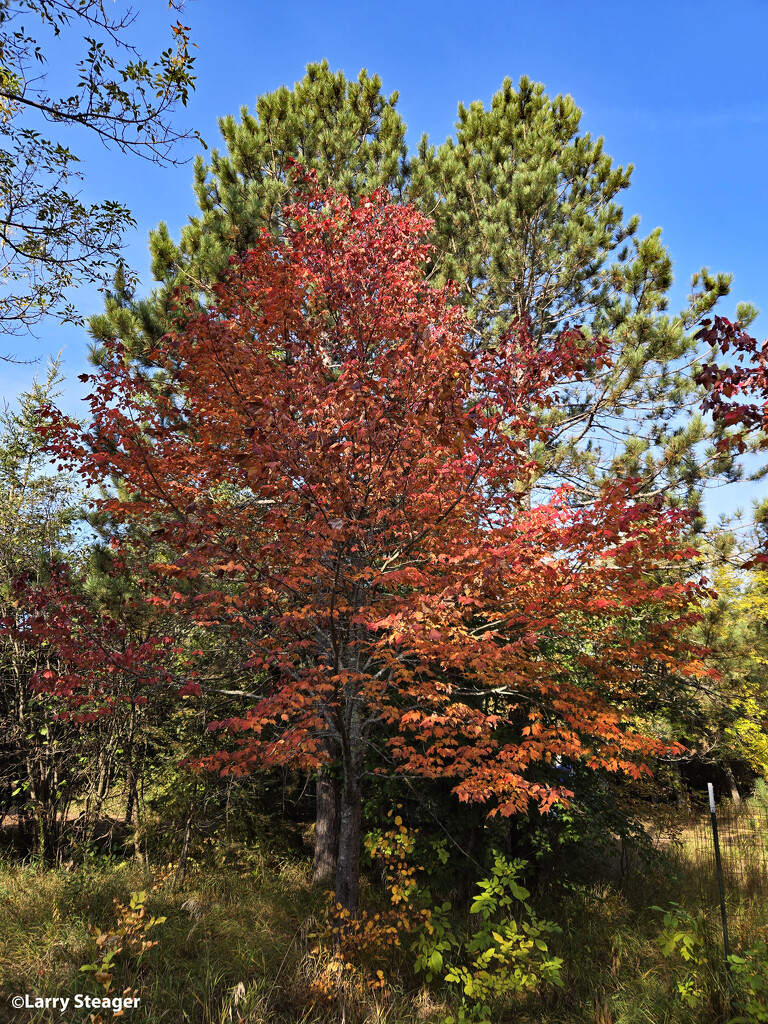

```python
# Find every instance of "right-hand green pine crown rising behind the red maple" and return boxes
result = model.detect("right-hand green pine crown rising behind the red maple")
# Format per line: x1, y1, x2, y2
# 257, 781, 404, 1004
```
409, 77, 730, 503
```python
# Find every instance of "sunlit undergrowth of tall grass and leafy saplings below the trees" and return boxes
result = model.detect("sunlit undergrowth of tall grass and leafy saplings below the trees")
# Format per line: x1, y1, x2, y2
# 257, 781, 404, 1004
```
0, 798, 768, 1024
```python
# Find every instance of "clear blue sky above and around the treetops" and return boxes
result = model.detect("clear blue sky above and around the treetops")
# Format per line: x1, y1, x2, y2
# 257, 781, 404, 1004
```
0, 0, 768, 520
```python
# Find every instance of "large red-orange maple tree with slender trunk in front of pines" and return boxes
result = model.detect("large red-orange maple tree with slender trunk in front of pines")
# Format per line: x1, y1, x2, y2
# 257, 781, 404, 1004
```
36, 184, 700, 910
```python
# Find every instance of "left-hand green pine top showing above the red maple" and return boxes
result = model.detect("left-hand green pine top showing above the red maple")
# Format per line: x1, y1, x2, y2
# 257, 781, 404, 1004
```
90, 60, 408, 361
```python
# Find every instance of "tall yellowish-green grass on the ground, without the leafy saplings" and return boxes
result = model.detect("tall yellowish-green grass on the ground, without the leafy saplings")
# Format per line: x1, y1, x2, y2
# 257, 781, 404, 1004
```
0, 808, 768, 1024
